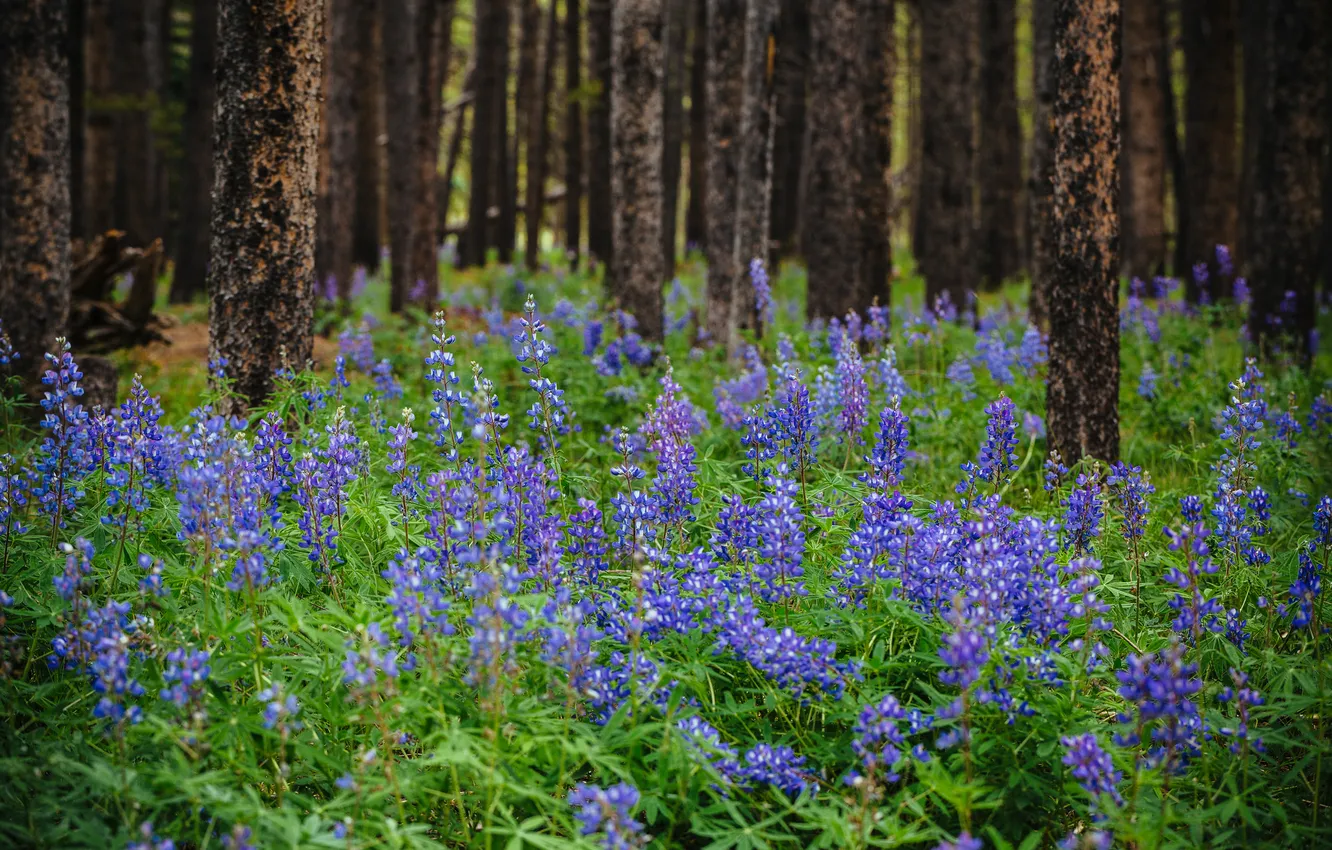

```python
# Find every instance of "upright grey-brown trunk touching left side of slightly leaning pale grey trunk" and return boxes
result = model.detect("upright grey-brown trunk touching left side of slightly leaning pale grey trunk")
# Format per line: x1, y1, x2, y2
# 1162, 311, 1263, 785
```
703, 0, 746, 348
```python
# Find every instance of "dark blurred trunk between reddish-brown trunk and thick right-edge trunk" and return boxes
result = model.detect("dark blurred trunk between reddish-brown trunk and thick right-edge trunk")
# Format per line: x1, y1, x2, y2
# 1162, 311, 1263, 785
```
1177, 0, 1240, 301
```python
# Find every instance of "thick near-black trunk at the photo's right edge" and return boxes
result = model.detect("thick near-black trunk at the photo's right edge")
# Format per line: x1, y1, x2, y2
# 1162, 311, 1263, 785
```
1248, 0, 1332, 364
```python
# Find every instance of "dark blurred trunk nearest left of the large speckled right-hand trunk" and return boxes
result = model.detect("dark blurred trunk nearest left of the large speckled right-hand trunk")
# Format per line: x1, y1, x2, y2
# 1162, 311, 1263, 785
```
976, 0, 1023, 289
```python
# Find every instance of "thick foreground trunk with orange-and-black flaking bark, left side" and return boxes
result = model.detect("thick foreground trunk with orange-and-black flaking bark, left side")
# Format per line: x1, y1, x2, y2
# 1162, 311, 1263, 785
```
208, 0, 324, 408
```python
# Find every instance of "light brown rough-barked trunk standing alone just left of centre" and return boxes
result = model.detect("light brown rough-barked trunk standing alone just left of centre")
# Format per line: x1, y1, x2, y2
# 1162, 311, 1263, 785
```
610, 0, 666, 340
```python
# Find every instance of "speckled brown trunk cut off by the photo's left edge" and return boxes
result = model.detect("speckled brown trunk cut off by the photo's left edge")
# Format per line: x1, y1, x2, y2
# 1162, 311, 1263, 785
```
0, 0, 69, 378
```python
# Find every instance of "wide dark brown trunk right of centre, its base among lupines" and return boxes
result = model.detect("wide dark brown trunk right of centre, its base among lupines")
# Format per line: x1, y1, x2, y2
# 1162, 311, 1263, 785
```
801, 0, 868, 318
